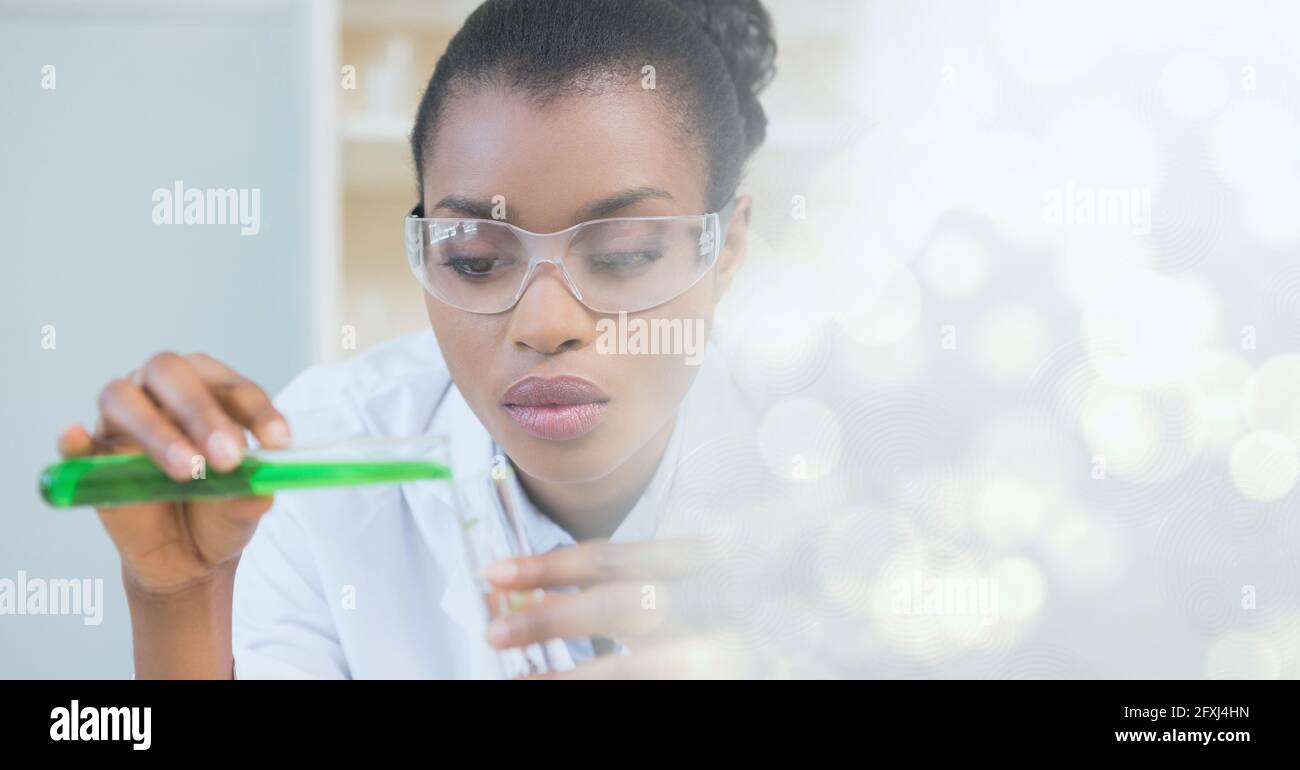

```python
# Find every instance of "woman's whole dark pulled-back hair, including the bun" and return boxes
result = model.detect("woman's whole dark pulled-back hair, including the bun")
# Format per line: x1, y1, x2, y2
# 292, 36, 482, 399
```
411, 0, 776, 207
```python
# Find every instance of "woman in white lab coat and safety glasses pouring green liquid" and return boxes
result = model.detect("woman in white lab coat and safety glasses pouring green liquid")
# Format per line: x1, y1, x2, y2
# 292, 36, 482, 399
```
60, 0, 775, 678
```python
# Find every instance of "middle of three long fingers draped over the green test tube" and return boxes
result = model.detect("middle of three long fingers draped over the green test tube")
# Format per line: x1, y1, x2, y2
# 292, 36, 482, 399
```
144, 352, 244, 471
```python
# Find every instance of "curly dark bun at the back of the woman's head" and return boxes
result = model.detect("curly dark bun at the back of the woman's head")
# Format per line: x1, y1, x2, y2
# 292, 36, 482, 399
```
670, 0, 776, 153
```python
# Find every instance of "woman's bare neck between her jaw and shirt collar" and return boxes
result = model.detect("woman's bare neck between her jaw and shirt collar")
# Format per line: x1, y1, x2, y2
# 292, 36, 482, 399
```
516, 419, 677, 541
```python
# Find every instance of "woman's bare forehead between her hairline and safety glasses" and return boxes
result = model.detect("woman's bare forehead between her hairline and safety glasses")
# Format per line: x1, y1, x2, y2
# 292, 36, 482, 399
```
421, 85, 706, 232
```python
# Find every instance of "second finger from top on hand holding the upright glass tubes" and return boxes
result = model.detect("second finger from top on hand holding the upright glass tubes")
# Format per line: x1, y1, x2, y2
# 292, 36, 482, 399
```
486, 581, 668, 649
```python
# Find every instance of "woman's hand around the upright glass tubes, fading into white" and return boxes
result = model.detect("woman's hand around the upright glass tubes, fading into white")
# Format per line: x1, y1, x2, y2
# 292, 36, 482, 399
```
485, 540, 737, 679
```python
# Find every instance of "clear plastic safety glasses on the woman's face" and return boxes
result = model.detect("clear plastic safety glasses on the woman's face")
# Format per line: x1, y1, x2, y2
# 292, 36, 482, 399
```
406, 196, 736, 313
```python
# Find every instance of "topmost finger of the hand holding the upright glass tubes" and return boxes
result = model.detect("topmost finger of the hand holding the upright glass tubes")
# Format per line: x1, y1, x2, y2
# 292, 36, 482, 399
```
484, 540, 706, 589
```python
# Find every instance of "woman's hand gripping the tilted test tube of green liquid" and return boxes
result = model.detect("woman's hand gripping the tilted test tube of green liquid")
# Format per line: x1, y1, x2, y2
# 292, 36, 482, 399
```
59, 352, 290, 597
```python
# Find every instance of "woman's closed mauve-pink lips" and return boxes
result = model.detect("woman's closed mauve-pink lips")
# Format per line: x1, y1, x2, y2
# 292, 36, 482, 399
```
501, 377, 610, 441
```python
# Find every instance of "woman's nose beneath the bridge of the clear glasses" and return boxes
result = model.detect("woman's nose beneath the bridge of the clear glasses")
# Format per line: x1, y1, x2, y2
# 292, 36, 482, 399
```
508, 264, 595, 355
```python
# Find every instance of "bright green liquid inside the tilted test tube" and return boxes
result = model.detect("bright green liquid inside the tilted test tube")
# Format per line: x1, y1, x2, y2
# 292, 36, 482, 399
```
40, 454, 451, 507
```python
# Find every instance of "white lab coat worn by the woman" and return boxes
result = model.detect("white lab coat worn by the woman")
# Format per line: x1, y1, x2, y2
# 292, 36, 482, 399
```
233, 330, 754, 679
